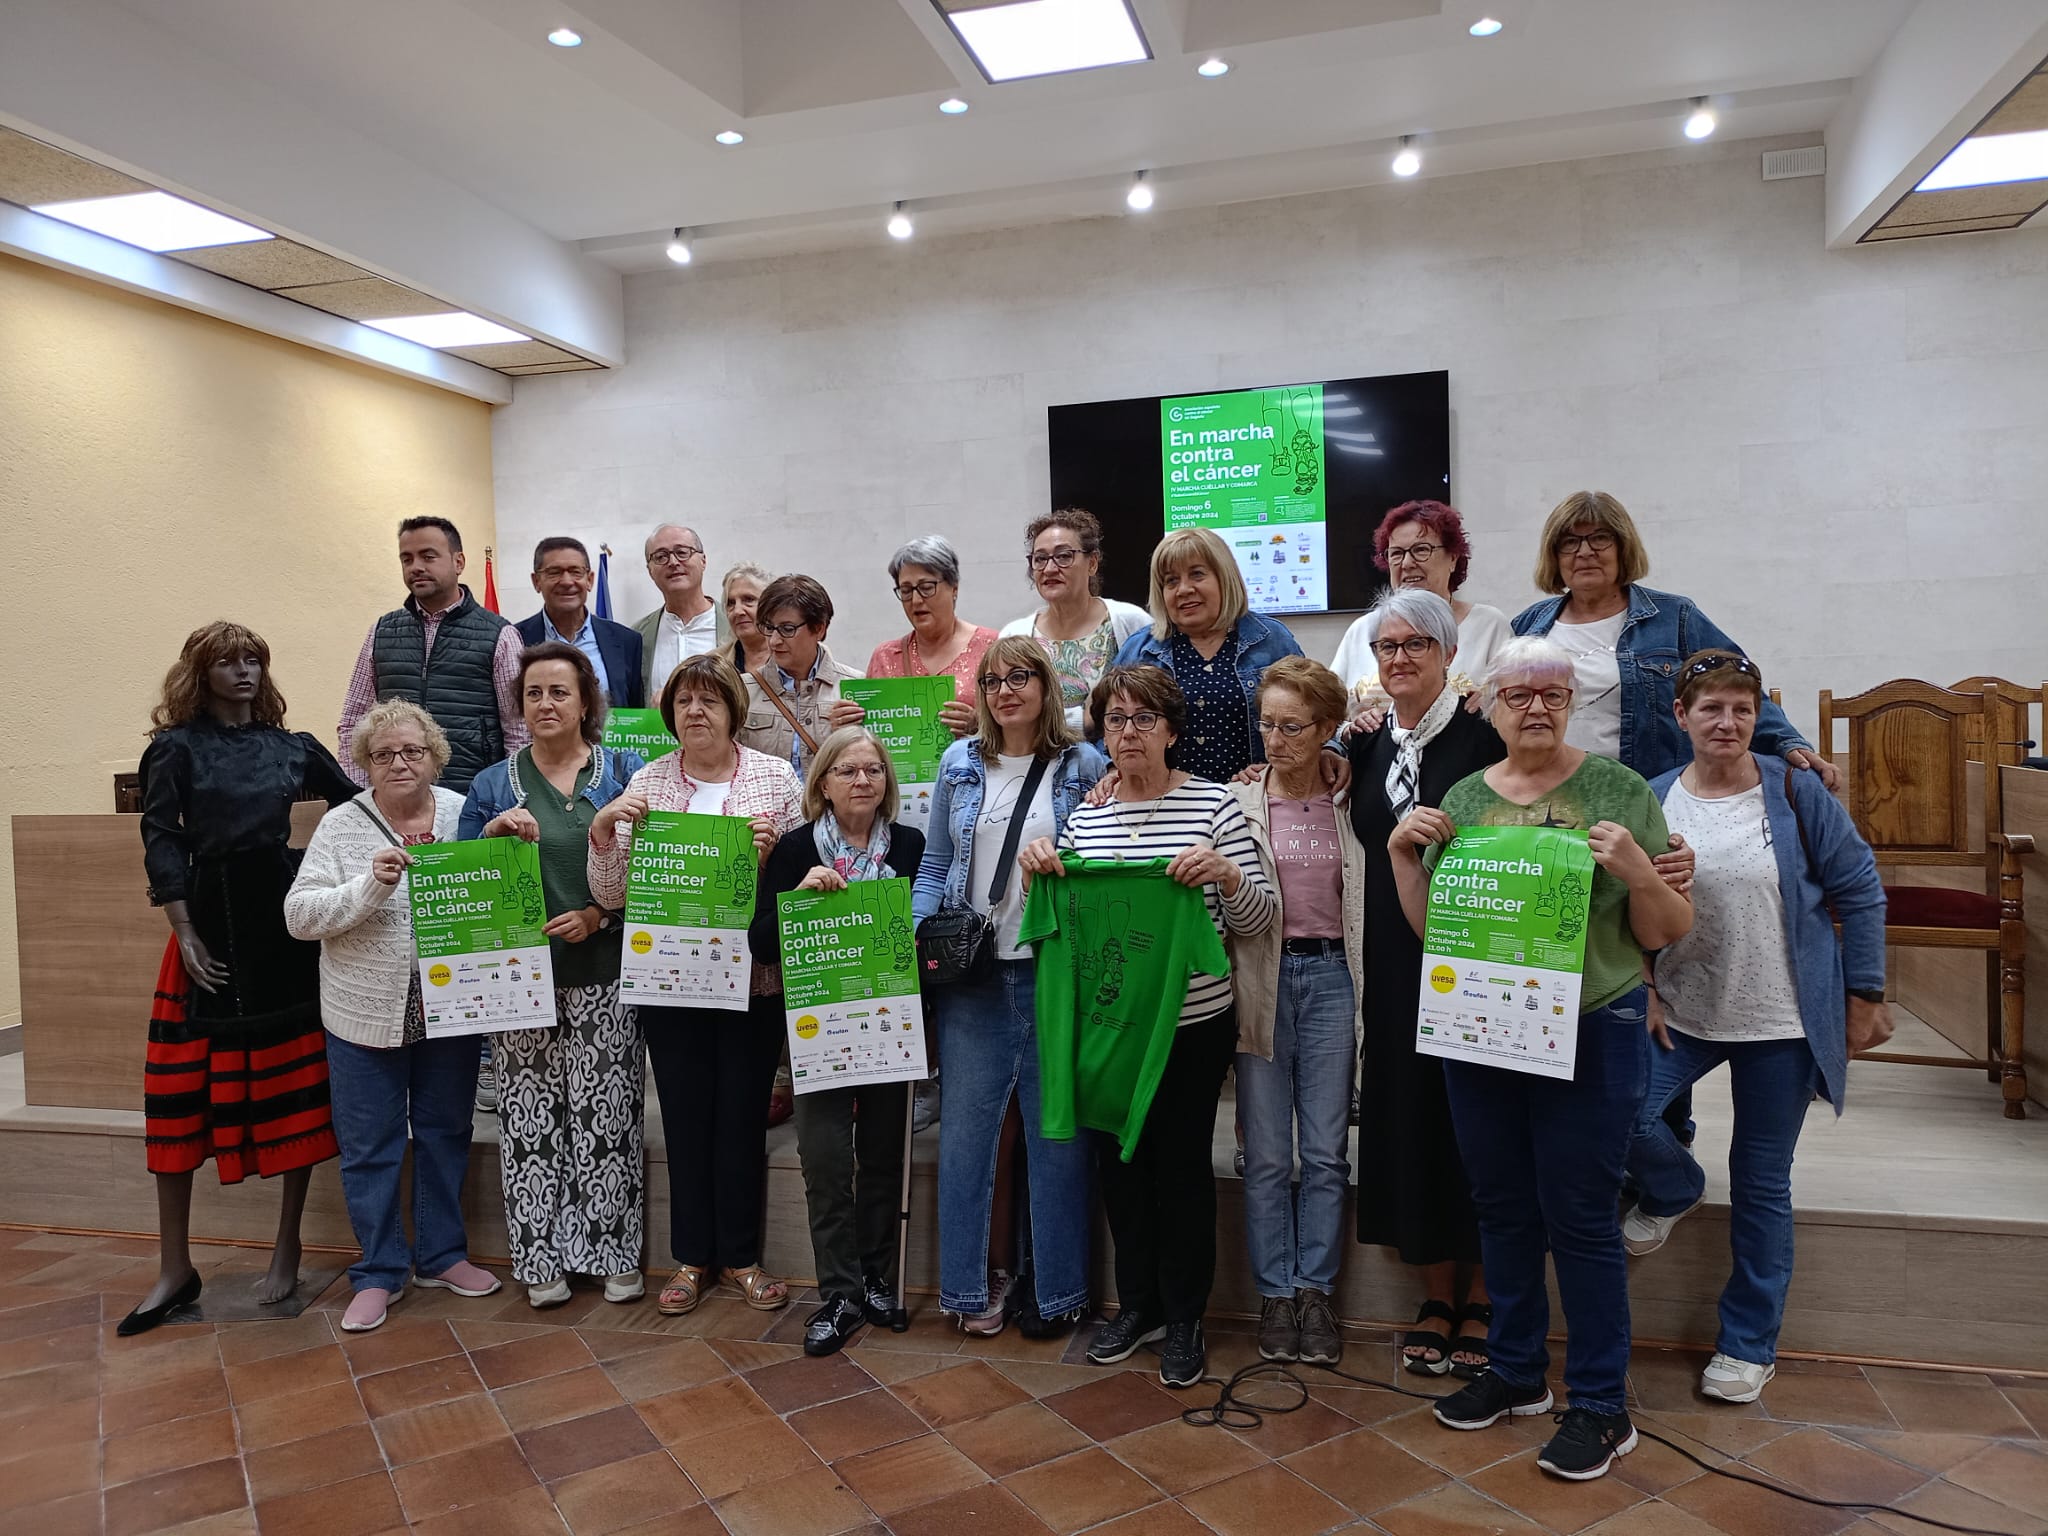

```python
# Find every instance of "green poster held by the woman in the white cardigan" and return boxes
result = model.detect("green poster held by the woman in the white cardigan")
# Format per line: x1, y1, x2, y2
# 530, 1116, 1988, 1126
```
406, 838, 555, 1036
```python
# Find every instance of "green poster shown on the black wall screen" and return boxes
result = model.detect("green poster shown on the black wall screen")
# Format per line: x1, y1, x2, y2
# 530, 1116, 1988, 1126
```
1159, 385, 1329, 612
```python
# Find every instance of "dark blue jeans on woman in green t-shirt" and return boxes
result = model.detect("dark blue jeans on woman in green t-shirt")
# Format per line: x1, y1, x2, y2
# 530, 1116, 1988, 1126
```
1444, 987, 1651, 1413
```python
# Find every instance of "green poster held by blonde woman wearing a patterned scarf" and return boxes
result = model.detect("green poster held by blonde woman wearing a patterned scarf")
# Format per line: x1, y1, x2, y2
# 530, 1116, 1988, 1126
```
776, 879, 926, 1094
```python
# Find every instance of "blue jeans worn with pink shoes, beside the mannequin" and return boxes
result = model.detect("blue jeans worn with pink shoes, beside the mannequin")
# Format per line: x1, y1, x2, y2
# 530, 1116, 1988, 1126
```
328, 1032, 481, 1290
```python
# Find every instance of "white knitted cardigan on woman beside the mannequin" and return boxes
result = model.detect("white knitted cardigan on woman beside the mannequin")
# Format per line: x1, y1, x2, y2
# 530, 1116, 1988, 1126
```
285, 786, 463, 1051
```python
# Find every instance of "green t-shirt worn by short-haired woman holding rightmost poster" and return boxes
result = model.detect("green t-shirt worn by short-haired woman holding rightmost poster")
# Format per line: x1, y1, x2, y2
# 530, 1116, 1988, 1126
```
1430, 752, 1669, 1014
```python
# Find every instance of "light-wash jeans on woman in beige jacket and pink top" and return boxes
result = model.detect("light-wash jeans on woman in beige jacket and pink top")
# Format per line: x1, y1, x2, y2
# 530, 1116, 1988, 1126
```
1237, 954, 1358, 1296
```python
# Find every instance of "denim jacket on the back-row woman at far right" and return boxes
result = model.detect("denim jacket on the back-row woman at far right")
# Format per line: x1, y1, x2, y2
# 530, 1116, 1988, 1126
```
1511, 586, 1812, 778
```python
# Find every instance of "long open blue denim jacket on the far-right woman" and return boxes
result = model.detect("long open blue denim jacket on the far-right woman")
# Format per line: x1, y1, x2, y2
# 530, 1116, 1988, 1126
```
1651, 752, 1884, 1114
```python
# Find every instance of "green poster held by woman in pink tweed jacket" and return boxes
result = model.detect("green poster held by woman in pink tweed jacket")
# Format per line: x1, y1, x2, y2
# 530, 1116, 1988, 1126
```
618, 811, 760, 1010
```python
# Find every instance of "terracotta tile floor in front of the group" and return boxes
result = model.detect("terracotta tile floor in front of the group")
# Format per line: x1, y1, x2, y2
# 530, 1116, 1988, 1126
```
12, 1229, 2048, 1536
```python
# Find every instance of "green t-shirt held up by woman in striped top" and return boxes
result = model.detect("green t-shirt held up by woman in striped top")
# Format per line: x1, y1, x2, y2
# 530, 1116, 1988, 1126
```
1018, 854, 1231, 1161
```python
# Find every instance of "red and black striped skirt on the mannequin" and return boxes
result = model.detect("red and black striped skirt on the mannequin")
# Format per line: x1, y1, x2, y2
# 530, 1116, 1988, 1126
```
143, 938, 338, 1184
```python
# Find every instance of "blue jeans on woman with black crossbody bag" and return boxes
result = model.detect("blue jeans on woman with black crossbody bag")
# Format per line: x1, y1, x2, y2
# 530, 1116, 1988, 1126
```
936, 961, 1094, 1317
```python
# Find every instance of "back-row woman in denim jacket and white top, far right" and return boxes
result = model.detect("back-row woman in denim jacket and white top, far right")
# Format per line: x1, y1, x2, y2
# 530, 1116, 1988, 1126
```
1513, 492, 1839, 788
